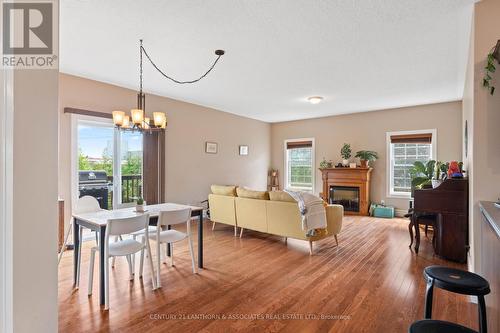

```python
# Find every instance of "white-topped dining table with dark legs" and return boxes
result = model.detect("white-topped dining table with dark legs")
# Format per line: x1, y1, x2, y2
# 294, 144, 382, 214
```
73, 203, 203, 305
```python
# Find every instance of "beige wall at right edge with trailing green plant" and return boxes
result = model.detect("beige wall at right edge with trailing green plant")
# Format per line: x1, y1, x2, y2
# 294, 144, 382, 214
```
464, 0, 500, 272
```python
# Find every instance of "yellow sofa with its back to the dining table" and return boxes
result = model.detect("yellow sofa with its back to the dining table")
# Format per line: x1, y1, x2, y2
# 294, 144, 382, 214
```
208, 185, 344, 254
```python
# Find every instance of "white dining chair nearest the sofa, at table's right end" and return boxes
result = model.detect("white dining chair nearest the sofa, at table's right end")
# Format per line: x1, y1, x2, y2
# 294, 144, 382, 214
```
140, 208, 197, 288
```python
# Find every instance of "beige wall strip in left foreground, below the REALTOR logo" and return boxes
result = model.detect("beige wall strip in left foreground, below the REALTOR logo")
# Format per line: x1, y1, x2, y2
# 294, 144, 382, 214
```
8, 69, 58, 332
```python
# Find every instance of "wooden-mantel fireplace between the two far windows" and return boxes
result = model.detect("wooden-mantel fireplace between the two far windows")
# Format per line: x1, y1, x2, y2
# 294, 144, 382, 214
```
321, 167, 372, 216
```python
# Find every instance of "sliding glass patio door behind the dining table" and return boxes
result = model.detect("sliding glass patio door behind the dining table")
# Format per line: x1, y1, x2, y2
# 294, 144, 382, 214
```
74, 118, 143, 209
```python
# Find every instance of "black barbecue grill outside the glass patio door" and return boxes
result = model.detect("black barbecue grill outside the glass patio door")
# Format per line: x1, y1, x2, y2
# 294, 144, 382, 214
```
78, 170, 111, 209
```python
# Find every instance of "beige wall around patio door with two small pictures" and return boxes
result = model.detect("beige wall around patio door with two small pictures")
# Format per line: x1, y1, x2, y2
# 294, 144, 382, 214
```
59, 74, 271, 227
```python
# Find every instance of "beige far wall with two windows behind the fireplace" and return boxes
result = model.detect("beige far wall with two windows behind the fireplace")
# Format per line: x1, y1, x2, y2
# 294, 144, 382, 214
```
271, 102, 462, 210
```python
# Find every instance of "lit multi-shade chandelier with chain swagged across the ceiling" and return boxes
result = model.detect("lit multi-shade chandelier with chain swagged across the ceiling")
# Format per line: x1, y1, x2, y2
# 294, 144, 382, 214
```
112, 39, 225, 133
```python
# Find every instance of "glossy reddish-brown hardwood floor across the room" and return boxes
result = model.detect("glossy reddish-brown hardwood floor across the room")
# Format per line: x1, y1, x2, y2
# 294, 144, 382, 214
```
59, 217, 477, 332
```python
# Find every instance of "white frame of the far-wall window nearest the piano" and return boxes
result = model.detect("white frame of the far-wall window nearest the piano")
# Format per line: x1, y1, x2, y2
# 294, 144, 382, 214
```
386, 128, 437, 199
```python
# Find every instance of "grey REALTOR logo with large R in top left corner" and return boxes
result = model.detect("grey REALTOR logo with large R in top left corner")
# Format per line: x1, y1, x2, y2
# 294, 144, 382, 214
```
2, 1, 57, 69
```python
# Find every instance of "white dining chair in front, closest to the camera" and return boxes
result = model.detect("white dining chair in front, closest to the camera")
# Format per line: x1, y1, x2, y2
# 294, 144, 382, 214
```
88, 214, 156, 310
